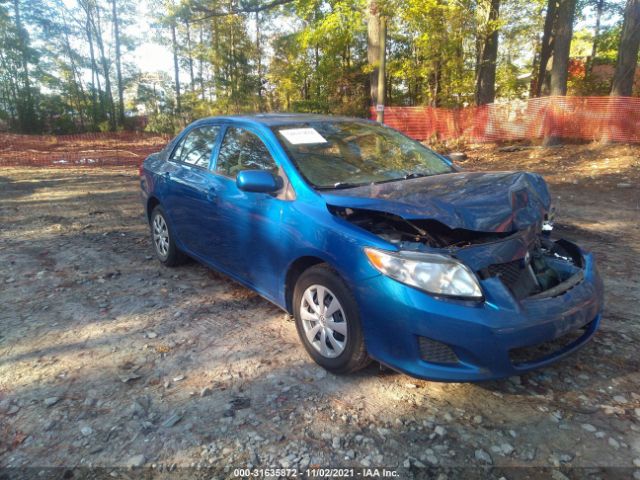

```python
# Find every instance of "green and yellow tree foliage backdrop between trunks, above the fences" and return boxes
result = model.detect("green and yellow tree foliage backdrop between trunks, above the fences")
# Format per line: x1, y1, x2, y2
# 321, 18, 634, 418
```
0, 0, 624, 133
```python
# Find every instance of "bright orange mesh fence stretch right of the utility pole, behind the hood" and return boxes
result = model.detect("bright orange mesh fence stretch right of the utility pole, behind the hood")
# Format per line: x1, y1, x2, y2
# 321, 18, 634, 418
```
371, 97, 640, 143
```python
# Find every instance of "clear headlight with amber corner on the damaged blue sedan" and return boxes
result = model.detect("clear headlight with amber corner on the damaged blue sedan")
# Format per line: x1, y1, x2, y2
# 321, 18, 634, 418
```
364, 248, 482, 298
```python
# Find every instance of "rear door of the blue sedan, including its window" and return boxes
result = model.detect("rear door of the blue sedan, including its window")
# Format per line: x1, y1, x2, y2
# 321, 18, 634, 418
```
165, 125, 220, 255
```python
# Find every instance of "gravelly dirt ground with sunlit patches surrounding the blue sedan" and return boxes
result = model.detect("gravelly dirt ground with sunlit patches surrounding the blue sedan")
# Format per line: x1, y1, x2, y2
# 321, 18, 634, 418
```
0, 141, 640, 479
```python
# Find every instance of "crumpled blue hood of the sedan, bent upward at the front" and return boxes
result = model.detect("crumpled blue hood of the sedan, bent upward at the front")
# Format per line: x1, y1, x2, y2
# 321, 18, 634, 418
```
322, 172, 551, 232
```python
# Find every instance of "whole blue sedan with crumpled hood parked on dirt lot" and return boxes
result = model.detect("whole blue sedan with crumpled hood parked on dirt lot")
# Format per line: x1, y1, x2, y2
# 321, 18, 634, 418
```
141, 114, 603, 381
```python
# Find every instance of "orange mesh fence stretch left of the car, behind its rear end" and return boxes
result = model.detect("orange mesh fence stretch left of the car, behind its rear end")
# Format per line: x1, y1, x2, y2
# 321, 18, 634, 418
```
0, 132, 171, 167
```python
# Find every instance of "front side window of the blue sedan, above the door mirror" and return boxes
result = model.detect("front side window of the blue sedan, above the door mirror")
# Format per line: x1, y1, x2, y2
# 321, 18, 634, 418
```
216, 127, 278, 178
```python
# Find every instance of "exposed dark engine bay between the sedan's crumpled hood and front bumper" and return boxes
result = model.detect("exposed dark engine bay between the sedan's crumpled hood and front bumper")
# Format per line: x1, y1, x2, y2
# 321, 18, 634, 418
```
328, 206, 584, 300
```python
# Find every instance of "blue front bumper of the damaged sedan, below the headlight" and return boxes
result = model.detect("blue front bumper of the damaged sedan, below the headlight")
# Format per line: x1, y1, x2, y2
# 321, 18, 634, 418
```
355, 246, 603, 381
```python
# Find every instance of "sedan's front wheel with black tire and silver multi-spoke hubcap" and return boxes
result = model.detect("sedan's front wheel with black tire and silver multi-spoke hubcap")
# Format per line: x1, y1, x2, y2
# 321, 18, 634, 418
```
293, 264, 371, 373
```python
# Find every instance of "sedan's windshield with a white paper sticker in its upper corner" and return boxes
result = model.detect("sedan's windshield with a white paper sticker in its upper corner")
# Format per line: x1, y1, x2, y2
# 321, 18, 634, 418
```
273, 121, 453, 189
